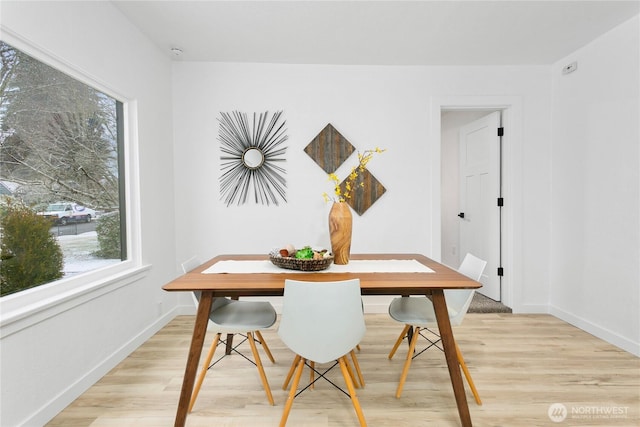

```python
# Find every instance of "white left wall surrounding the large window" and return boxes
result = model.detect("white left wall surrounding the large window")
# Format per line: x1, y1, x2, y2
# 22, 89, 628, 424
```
0, 1, 177, 426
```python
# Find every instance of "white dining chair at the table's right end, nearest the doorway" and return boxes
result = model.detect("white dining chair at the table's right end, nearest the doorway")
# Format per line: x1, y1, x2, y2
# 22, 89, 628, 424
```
389, 254, 487, 405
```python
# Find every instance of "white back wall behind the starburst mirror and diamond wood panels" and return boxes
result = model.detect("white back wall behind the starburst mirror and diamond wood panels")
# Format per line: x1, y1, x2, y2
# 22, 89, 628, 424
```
173, 62, 551, 312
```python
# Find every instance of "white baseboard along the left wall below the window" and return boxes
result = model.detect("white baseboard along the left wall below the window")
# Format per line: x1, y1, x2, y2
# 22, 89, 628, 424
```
20, 308, 181, 426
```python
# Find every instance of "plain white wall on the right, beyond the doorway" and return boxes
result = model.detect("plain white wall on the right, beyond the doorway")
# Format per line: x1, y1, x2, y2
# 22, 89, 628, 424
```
549, 17, 640, 355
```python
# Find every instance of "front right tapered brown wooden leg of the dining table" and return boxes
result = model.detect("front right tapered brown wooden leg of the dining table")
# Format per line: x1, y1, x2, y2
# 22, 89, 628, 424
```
431, 289, 471, 427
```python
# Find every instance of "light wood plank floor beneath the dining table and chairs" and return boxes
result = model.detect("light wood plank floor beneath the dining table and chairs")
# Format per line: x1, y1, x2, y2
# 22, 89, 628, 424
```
48, 313, 640, 427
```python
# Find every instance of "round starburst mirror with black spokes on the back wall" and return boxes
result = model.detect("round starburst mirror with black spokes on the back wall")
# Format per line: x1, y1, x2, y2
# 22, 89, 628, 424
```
218, 111, 288, 206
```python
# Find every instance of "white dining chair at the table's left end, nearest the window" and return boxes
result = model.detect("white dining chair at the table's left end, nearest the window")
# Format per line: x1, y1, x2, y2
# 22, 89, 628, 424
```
182, 258, 277, 412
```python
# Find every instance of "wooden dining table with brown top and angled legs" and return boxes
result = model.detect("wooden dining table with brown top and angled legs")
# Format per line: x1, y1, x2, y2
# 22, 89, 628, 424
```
163, 254, 482, 427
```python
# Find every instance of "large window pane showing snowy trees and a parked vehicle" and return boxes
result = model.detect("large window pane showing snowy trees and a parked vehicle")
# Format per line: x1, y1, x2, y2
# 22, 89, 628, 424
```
0, 40, 127, 296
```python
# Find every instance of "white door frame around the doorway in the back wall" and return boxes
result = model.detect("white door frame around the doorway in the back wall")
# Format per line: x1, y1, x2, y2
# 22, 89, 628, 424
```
430, 96, 523, 307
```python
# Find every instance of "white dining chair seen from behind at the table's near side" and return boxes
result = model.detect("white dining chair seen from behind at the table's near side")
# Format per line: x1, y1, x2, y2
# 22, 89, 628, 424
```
278, 279, 367, 427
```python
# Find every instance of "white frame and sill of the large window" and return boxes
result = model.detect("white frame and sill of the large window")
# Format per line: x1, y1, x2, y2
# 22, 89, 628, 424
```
0, 32, 145, 338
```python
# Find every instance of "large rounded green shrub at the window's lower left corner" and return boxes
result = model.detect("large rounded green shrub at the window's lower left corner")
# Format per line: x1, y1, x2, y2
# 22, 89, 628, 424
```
0, 200, 64, 296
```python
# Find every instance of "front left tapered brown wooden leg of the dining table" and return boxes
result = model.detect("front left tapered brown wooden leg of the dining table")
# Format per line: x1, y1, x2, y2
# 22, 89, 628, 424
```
174, 291, 213, 427
